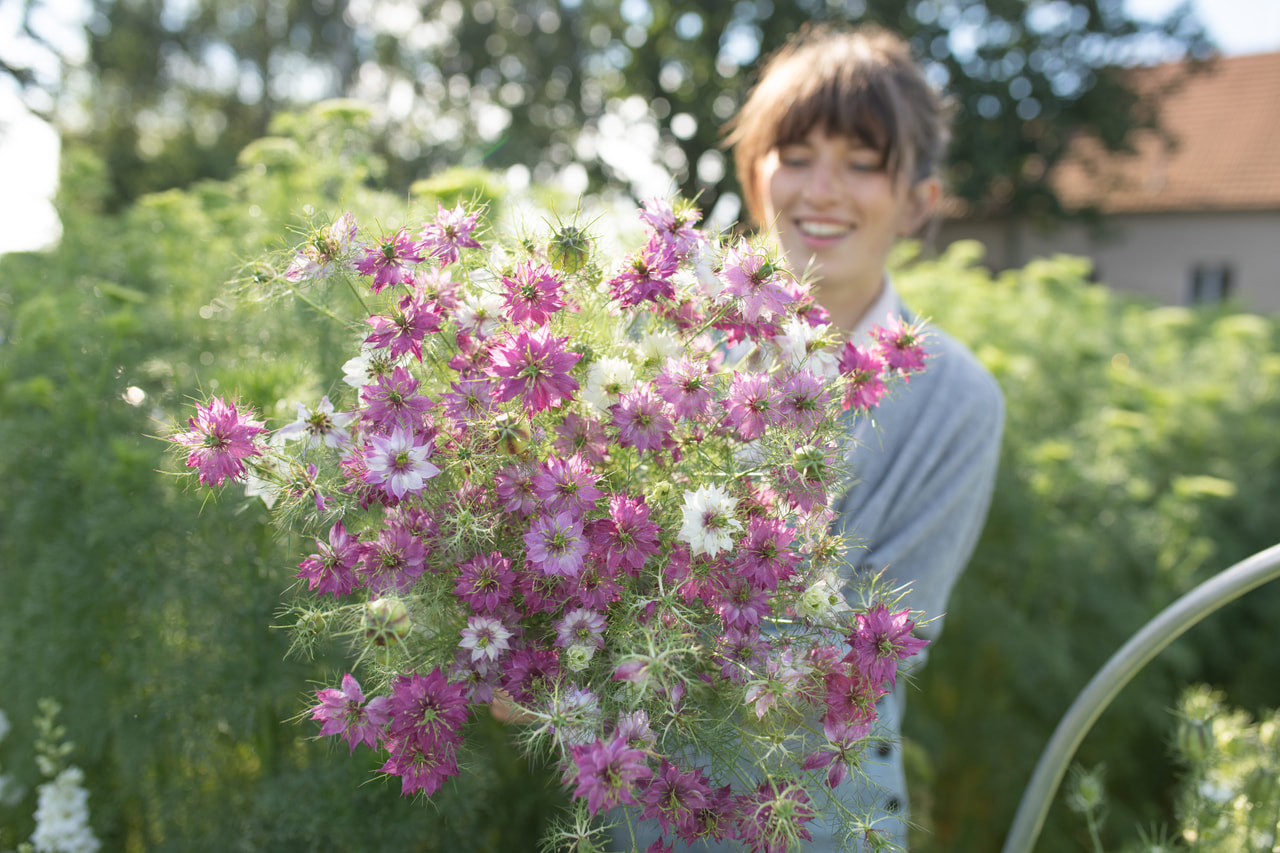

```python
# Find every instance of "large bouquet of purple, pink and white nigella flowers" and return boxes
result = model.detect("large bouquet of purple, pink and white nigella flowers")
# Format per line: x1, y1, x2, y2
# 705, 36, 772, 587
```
172, 200, 923, 850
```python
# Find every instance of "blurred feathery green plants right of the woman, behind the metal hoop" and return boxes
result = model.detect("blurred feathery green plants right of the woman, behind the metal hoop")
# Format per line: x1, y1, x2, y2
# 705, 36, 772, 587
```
899, 243, 1280, 852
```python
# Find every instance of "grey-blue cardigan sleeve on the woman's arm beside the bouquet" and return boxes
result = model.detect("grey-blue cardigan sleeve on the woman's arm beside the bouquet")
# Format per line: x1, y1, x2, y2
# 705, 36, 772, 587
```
836, 329, 1004, 638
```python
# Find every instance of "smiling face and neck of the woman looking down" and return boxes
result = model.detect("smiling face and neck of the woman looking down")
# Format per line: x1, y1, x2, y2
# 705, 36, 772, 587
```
759, 128, 924, 328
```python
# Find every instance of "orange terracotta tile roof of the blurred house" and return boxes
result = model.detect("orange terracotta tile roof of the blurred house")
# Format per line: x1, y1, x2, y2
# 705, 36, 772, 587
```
1053, 53, 1280, 213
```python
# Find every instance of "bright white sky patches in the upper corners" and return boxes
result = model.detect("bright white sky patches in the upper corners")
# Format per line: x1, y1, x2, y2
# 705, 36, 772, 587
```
0, 0, 1280, 254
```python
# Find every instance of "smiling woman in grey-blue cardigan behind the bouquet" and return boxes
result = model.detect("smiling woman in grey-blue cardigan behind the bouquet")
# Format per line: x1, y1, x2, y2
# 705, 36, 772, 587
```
645, 27, 1004, 850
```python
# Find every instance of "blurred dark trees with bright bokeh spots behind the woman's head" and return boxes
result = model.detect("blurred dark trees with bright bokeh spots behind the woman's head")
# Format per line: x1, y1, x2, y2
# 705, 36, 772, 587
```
0, 0, 1211, 219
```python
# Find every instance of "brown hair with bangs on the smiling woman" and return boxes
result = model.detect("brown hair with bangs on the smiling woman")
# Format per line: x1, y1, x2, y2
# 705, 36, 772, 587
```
724, 26, 950, 222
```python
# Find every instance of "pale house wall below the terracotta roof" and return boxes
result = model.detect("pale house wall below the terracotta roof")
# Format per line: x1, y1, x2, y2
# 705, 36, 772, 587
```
936, 210, 1280, 313
